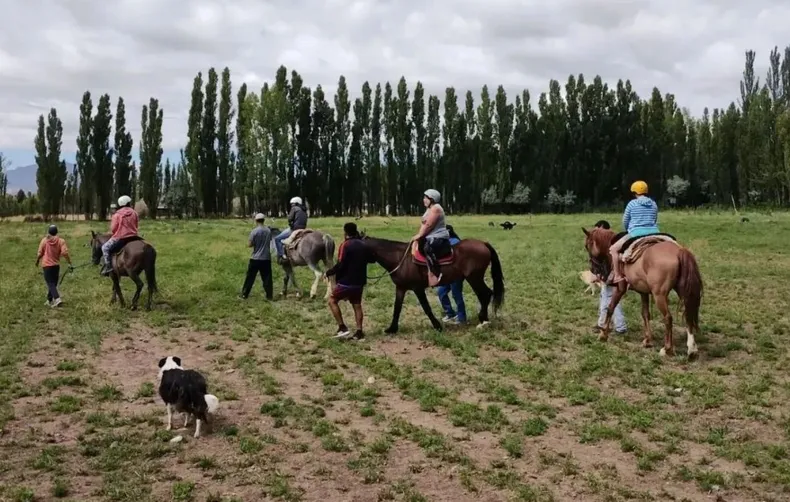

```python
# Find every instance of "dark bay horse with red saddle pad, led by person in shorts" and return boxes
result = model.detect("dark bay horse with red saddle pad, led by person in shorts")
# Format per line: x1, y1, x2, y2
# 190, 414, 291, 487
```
363, 236, 505, 334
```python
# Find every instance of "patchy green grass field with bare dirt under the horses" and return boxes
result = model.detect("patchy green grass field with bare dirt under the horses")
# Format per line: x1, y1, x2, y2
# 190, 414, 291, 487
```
0, 213, 790, 502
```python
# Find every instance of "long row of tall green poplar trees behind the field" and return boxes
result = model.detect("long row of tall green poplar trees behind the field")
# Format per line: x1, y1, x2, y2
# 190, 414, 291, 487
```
4, 47, 790, 218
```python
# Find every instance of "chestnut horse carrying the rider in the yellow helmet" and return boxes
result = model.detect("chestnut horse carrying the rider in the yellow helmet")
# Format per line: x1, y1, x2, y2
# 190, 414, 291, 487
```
582, 228, 702, 359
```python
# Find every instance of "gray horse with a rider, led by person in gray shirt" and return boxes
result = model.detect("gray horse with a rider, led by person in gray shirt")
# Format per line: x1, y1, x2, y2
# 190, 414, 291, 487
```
271, 228, 335, 299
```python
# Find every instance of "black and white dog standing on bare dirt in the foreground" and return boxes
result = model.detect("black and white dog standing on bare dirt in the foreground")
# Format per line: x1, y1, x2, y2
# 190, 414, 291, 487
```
159, 356, 219, 437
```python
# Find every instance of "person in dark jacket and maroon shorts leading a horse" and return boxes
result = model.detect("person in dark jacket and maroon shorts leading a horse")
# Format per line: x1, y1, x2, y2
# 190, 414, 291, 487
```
326, 222, 374, 340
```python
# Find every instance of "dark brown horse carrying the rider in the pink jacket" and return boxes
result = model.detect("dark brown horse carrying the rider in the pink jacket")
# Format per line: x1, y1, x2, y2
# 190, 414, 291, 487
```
90, 231, 157, 310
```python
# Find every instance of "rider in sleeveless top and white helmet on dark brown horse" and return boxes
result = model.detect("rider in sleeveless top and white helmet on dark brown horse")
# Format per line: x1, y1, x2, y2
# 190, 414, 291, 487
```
412, 188, 452, 286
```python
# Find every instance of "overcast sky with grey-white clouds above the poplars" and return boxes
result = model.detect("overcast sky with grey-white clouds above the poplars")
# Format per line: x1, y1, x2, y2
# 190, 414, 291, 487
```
0, 0, 790, 166
